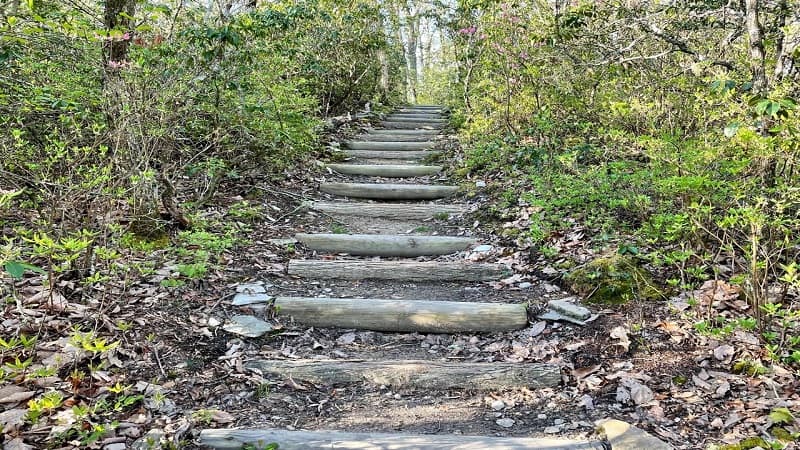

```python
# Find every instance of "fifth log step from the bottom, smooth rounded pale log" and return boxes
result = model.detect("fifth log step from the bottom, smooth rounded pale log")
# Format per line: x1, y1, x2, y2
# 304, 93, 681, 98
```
295, 233, 477, 257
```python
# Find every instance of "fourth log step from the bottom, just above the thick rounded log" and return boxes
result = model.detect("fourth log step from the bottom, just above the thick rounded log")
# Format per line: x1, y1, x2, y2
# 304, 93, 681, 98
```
289, 259, 511, 281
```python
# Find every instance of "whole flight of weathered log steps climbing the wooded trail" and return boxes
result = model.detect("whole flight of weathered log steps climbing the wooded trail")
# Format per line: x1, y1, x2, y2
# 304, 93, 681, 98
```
200, 105, 663, 450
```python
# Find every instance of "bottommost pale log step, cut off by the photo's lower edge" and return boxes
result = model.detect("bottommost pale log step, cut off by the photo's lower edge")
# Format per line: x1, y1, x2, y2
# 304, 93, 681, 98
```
200, 428, 606, 450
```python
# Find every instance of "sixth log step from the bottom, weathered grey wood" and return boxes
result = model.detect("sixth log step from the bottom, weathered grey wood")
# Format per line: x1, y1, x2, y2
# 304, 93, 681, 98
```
311, 202, 466, 220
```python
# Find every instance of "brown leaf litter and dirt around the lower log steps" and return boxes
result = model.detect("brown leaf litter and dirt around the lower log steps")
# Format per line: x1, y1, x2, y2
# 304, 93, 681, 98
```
0, 119, 800, 450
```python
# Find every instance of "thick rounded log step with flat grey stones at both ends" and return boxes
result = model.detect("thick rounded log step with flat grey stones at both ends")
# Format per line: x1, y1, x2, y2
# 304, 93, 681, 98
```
274, 297, 528, 333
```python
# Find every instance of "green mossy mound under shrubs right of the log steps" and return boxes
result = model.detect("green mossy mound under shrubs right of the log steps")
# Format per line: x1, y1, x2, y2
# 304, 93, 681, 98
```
566, 255, 663, 304
